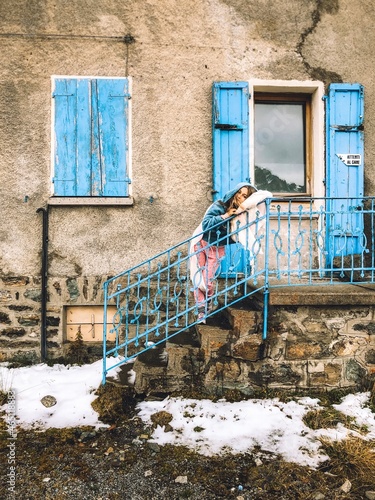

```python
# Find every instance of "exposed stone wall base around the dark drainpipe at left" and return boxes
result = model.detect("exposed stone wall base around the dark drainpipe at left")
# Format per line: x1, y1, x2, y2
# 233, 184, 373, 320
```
0, 275, 108, 363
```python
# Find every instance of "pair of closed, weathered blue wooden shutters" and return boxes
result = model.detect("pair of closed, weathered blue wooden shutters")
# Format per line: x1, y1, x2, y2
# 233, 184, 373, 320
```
52, 77, 130, 200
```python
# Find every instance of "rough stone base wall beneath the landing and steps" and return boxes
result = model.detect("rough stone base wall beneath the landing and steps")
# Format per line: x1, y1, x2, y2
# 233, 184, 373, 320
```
134, 300, 375, 395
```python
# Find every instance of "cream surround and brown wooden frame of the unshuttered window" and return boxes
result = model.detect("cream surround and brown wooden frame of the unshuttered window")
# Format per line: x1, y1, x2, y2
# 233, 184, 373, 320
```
249, 80, 325, 198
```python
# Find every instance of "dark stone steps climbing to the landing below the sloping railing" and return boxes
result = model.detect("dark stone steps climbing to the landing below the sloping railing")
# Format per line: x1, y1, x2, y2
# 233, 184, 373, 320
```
108, 300, 266, 397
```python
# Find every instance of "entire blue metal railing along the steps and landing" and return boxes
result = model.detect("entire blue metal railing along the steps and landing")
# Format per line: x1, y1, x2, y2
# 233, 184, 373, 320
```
103, 198, 375, 383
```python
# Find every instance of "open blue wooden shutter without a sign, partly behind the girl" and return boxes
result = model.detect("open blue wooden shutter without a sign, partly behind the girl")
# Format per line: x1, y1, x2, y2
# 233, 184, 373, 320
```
212, 82, 250, 276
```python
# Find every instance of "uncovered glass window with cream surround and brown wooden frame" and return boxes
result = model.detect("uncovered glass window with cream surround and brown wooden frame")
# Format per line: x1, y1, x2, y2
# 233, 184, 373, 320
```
249, 80, 325, 197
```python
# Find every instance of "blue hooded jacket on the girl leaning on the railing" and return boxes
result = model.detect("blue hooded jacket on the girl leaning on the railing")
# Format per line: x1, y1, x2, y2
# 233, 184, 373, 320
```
202, 182, 254, 246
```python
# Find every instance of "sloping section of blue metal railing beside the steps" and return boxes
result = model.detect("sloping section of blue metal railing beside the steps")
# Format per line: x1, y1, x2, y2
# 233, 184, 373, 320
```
103, 205, 266, 383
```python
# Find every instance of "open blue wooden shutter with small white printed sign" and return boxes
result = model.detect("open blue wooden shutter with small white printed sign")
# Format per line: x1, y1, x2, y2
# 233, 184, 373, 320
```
326, 83, 364, 263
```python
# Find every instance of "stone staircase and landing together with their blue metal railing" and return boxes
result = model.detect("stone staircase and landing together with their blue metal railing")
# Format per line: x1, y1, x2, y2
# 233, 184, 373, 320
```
103, 199, 375, 394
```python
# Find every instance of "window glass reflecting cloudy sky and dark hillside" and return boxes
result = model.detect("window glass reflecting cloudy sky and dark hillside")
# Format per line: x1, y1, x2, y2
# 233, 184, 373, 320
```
255, 102, 306, 193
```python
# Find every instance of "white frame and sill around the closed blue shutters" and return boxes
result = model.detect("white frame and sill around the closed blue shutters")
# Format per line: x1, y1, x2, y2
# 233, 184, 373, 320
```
48, 75, 134, 205
